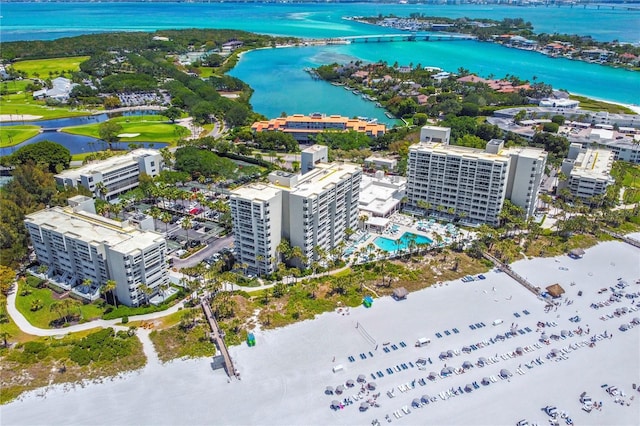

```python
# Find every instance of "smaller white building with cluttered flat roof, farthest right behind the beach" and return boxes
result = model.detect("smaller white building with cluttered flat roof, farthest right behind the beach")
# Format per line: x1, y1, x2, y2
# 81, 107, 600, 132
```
558, 144, 614, 201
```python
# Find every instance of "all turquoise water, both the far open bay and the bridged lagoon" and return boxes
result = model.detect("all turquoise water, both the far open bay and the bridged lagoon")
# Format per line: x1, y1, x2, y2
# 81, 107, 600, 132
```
0, 2, 640, 120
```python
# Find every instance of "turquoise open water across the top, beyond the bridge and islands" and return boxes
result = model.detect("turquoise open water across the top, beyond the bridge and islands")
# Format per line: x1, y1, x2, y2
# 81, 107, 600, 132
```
0, 2, 640, 43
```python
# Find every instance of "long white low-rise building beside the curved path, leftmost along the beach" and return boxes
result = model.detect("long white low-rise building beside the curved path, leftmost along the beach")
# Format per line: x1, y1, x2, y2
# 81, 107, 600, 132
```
25, 195, 169, 306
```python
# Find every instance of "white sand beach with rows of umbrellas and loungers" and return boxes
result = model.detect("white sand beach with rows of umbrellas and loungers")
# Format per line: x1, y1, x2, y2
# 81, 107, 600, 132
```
2, 242, 640, 425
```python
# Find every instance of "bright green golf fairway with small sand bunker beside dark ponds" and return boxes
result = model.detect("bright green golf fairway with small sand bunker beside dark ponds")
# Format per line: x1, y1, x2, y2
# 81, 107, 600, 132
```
62, 115, 189, 143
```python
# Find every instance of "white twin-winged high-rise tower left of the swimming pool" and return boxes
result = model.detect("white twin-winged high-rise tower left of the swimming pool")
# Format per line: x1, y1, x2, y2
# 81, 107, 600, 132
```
229, 150, 362, 274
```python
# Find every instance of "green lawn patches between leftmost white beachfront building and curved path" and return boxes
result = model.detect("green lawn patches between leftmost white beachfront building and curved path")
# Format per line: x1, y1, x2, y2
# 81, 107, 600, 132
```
16, 281, 104, 328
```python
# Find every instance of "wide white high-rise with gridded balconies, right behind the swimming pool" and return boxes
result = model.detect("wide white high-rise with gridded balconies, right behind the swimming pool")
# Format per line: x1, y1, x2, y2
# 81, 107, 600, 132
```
406, 140, 547, 225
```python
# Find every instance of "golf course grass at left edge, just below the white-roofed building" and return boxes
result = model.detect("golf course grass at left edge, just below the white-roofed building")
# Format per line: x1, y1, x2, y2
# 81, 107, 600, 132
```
0, 92, 91, 121
